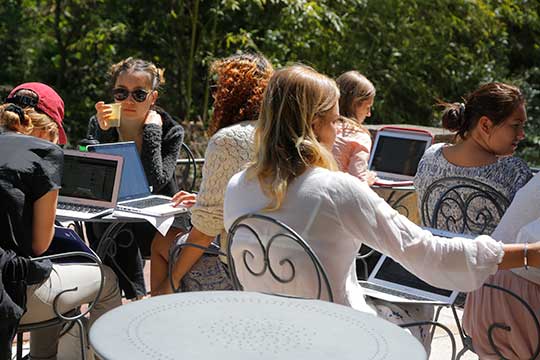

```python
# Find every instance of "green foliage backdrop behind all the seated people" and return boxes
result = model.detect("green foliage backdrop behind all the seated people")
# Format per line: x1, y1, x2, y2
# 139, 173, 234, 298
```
0, 0, 540, 164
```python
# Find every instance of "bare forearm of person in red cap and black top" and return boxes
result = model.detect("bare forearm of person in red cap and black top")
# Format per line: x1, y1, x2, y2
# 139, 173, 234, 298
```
32, 190, 59, 256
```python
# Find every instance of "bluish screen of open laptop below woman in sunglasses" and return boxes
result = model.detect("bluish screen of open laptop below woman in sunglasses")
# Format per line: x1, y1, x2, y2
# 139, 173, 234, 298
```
88, 142, 150, 201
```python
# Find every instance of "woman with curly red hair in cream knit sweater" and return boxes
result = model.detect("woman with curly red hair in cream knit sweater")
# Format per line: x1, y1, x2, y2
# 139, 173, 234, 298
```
151, 54, 273, 295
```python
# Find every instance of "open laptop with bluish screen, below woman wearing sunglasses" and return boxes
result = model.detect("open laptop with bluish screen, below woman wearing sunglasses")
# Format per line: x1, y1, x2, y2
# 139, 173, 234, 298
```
87, 141, 187, 216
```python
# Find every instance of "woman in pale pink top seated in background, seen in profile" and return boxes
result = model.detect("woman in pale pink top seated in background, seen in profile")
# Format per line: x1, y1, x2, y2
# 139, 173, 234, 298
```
332, 71, 375, 185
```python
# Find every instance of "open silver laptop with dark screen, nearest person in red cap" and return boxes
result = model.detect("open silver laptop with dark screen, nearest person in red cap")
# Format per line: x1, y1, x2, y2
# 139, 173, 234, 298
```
56, 150, 123, 220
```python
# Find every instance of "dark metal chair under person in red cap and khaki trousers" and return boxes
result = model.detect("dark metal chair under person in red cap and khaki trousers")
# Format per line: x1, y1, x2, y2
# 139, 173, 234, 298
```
17, 251, 105, 360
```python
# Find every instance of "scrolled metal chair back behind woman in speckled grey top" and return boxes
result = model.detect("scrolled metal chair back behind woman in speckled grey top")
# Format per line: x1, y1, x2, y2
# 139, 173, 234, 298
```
420, 177, 510, 235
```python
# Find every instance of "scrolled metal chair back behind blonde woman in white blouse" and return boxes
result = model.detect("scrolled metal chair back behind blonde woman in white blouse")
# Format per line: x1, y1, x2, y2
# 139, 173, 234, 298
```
227, 213, 334, 302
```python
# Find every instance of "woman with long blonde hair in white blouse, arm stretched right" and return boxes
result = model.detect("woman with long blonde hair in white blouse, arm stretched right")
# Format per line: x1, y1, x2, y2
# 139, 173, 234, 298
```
224, 65, 540, 352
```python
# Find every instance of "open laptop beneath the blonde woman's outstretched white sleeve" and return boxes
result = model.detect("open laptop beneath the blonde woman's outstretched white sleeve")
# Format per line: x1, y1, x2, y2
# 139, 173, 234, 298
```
358, 228, 463, 305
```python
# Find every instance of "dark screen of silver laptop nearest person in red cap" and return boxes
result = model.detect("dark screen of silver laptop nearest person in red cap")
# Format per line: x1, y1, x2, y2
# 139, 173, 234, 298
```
60, 153, 118, 202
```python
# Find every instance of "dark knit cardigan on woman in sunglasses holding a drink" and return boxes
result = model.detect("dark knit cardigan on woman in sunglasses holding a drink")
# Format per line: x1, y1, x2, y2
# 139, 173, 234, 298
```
87, 107, 184, 196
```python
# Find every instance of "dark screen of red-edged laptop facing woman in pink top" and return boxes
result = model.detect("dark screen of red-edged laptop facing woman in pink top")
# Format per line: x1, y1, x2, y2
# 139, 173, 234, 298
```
370, 134, 426, 176
